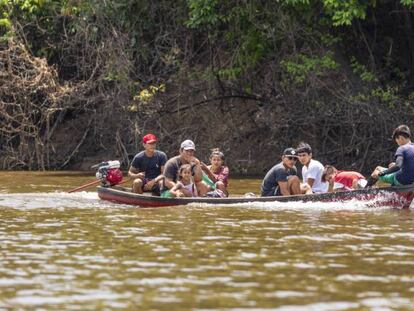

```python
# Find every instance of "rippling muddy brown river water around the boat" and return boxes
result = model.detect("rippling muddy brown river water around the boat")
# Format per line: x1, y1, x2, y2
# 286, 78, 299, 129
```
0, 172, 414, 311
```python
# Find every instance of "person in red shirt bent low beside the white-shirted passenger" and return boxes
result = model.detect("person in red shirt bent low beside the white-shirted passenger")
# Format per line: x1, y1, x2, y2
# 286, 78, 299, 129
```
322, 165, 367, 192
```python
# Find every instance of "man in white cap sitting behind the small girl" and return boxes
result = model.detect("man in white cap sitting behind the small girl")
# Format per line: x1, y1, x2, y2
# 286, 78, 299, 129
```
161, 139, 211, 197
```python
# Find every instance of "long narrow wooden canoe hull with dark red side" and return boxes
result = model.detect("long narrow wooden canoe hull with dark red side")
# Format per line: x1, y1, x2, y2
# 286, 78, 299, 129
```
98, 184, 414, 208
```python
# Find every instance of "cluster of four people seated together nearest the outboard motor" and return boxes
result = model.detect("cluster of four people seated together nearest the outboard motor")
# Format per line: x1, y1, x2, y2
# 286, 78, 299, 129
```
128, 134, 229, 197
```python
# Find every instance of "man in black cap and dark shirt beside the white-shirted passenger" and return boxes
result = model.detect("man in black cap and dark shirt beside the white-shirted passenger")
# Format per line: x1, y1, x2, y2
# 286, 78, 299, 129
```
261, 148, 301, 197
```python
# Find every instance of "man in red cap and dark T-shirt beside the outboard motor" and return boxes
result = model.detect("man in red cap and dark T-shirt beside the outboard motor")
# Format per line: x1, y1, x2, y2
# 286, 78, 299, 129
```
128, 134, 167, 195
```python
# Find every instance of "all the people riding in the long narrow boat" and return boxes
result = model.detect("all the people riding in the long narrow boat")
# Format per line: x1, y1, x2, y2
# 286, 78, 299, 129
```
128, 125, 414, 197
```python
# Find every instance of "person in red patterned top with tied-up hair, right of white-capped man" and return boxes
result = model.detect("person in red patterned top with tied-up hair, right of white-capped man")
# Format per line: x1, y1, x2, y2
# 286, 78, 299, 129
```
201, 148, 229, 196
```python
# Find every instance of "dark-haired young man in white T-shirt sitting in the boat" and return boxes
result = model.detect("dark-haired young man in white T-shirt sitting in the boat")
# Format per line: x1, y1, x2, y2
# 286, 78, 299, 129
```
296, 142, 327, 194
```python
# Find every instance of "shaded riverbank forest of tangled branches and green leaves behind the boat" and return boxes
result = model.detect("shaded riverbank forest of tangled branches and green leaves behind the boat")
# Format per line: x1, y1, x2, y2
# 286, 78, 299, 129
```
0, 0, 414, 174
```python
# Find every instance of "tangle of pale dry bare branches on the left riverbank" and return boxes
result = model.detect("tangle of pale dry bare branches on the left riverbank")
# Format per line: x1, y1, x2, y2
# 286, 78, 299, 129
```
0, 39, 70, 169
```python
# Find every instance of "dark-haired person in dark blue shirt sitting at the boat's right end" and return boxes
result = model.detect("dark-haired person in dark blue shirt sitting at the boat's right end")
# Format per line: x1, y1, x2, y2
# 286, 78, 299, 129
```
367, 125, 414, 187
